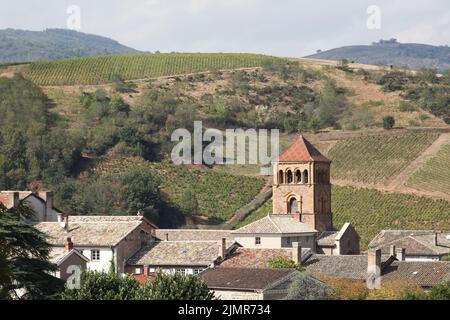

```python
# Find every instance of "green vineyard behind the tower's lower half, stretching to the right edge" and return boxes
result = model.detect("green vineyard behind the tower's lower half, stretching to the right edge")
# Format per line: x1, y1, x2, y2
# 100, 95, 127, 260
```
239, 186, 450, 250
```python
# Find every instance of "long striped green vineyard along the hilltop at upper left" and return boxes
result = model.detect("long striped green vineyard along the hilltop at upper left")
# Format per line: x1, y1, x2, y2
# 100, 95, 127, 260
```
24, 53, 277, 86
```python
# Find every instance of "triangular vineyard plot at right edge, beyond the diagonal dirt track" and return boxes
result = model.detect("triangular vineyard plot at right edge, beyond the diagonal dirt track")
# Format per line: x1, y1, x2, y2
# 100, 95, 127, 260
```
406, 144, 450, 195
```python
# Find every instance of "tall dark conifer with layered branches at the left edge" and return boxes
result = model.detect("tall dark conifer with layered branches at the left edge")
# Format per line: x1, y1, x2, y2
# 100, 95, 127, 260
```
0, 203, 64, 300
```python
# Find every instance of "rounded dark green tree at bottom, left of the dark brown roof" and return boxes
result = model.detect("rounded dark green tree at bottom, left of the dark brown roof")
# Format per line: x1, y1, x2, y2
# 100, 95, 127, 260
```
136, 271, 214, 300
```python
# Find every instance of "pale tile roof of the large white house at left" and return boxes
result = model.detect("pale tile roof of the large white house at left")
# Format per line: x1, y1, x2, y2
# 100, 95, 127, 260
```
35, 217, 142, 247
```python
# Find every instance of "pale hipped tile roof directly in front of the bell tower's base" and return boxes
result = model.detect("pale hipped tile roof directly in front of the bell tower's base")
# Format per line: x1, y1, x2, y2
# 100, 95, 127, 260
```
231, 214, 317, 235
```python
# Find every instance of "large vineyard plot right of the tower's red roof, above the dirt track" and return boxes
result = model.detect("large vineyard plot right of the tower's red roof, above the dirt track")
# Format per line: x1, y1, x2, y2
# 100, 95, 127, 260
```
328, 132, 439, 185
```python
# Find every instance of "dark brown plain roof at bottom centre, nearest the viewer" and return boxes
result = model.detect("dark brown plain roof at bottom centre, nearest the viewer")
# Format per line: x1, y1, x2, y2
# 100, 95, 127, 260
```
200, 268, 298, 291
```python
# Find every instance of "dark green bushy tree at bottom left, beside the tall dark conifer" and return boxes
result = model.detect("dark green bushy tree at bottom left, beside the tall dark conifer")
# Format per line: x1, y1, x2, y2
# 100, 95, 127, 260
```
61, 271, 139, 300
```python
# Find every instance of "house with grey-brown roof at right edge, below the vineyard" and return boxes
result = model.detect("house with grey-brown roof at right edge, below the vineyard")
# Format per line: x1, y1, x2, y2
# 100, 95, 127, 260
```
369, 230, 450, 261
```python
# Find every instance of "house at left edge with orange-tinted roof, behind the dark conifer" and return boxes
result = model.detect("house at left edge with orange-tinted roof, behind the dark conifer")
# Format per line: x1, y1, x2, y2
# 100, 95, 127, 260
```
0, 191, 62, 223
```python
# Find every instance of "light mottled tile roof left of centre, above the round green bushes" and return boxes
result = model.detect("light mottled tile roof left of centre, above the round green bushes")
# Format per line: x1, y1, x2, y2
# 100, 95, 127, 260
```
128, 241, 234, 266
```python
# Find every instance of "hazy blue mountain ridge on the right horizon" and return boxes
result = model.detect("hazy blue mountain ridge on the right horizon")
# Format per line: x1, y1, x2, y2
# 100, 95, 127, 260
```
307, 39, 450, 72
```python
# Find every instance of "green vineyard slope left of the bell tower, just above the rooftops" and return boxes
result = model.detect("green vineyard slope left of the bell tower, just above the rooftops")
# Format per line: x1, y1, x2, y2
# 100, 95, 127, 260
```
94, 159, 265, 221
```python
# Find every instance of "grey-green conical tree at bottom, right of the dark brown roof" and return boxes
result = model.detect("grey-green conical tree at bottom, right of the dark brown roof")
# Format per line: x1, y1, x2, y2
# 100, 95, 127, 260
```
285, 272, 333, 300
